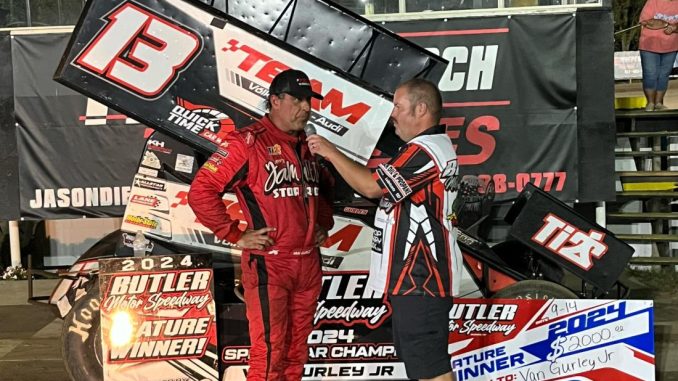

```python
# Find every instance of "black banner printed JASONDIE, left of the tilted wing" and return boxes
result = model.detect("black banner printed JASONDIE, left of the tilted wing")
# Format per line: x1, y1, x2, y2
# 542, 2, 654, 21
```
12, 34, 144, 219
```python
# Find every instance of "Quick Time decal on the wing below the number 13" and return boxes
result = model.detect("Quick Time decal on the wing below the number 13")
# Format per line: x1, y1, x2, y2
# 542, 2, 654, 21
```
167, 98, 235, 145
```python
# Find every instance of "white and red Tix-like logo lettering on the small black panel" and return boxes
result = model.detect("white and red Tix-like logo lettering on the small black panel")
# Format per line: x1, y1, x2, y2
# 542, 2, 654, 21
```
532, 213, 608, 270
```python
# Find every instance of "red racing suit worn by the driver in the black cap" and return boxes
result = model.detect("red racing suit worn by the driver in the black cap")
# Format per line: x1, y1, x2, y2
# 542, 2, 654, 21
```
188, 117, 333, 380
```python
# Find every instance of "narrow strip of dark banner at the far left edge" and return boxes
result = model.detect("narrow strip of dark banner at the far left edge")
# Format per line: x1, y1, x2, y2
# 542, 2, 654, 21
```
0, 32, 19, 220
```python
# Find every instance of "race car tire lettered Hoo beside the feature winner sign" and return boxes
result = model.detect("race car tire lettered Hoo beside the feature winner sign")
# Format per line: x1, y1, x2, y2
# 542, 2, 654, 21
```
61, 279, 104, 381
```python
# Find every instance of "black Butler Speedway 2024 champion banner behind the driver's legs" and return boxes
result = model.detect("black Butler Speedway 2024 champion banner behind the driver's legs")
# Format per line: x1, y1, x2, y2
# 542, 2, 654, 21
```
219, 272, 408, 381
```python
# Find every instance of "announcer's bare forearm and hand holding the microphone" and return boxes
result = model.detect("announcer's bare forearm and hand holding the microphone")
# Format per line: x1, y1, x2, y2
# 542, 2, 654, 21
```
306, 135, 382, 198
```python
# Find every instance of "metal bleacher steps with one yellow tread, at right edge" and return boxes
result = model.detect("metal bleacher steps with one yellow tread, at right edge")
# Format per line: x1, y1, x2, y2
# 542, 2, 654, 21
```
606, 109, 678, 265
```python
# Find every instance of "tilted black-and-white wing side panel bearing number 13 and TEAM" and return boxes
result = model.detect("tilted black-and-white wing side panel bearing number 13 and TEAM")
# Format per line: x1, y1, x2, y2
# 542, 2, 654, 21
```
56, 0, 392, 163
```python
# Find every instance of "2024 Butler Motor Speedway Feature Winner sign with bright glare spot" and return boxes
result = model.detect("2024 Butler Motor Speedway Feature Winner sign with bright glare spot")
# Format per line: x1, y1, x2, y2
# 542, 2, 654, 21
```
99, 254, 219, 381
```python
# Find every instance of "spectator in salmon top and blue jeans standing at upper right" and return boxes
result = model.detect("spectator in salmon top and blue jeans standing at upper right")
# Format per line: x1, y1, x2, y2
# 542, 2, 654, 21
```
639, 0, 678, 111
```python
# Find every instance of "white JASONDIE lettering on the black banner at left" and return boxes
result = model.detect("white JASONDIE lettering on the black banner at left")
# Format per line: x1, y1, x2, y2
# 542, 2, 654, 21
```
28, 186, 131, 209
